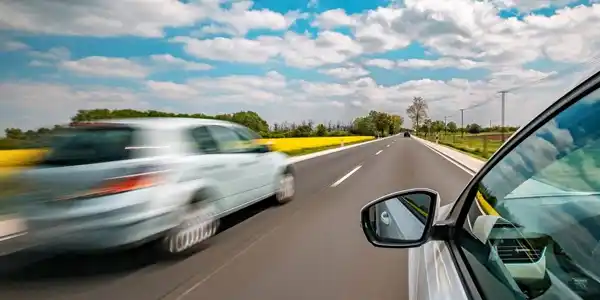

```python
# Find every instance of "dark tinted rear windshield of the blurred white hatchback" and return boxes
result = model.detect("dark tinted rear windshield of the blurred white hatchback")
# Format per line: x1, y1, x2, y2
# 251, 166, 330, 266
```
41, 127, 137, 166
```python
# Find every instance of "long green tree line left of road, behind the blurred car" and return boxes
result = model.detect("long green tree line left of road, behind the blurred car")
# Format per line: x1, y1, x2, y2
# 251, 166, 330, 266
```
0, 109, 404, 149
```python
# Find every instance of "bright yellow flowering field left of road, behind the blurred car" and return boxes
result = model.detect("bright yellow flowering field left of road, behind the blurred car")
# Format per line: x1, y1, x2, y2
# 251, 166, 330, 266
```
0, 136, 374, 169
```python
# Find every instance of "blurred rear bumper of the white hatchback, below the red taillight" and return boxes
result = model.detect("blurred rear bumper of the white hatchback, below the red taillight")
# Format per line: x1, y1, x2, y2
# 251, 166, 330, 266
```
17, 188, 180, 251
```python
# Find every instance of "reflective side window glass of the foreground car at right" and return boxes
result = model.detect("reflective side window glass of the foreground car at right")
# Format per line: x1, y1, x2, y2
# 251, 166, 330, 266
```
457, 86, 600, 300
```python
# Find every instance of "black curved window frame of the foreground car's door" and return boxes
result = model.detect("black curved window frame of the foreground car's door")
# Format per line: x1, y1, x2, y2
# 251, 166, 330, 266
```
434, 72, 600, 299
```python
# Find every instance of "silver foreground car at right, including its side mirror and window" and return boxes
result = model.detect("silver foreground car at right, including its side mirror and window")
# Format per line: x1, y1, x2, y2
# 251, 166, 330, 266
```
361, 72, 600, 300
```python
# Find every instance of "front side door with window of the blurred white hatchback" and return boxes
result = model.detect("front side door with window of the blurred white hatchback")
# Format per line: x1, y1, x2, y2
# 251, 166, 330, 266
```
208, 125, 261, 206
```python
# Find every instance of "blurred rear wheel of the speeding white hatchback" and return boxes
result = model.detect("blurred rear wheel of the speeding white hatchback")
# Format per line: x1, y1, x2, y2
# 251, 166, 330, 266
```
157, 195, 220, 258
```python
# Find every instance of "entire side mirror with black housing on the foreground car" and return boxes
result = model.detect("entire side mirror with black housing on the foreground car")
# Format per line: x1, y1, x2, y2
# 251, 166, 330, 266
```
360, 188, 439, 248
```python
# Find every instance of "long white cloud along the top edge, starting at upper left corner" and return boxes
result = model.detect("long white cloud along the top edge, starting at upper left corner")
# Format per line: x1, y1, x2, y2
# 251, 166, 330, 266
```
0, 0, 304, 37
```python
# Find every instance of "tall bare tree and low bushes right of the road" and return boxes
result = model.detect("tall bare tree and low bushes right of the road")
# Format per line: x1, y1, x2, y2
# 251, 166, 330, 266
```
406, 97, 518, 136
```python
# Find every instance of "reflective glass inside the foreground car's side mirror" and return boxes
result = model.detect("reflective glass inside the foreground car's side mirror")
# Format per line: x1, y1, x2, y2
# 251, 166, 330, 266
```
368, 192, 435, 243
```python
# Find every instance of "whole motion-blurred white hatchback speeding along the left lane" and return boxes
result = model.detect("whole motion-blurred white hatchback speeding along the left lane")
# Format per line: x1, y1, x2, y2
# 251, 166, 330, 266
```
12, 118, 294, 254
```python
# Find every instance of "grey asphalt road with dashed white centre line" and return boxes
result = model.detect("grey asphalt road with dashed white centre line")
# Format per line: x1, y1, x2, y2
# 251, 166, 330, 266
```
0, 137, 471, 300
